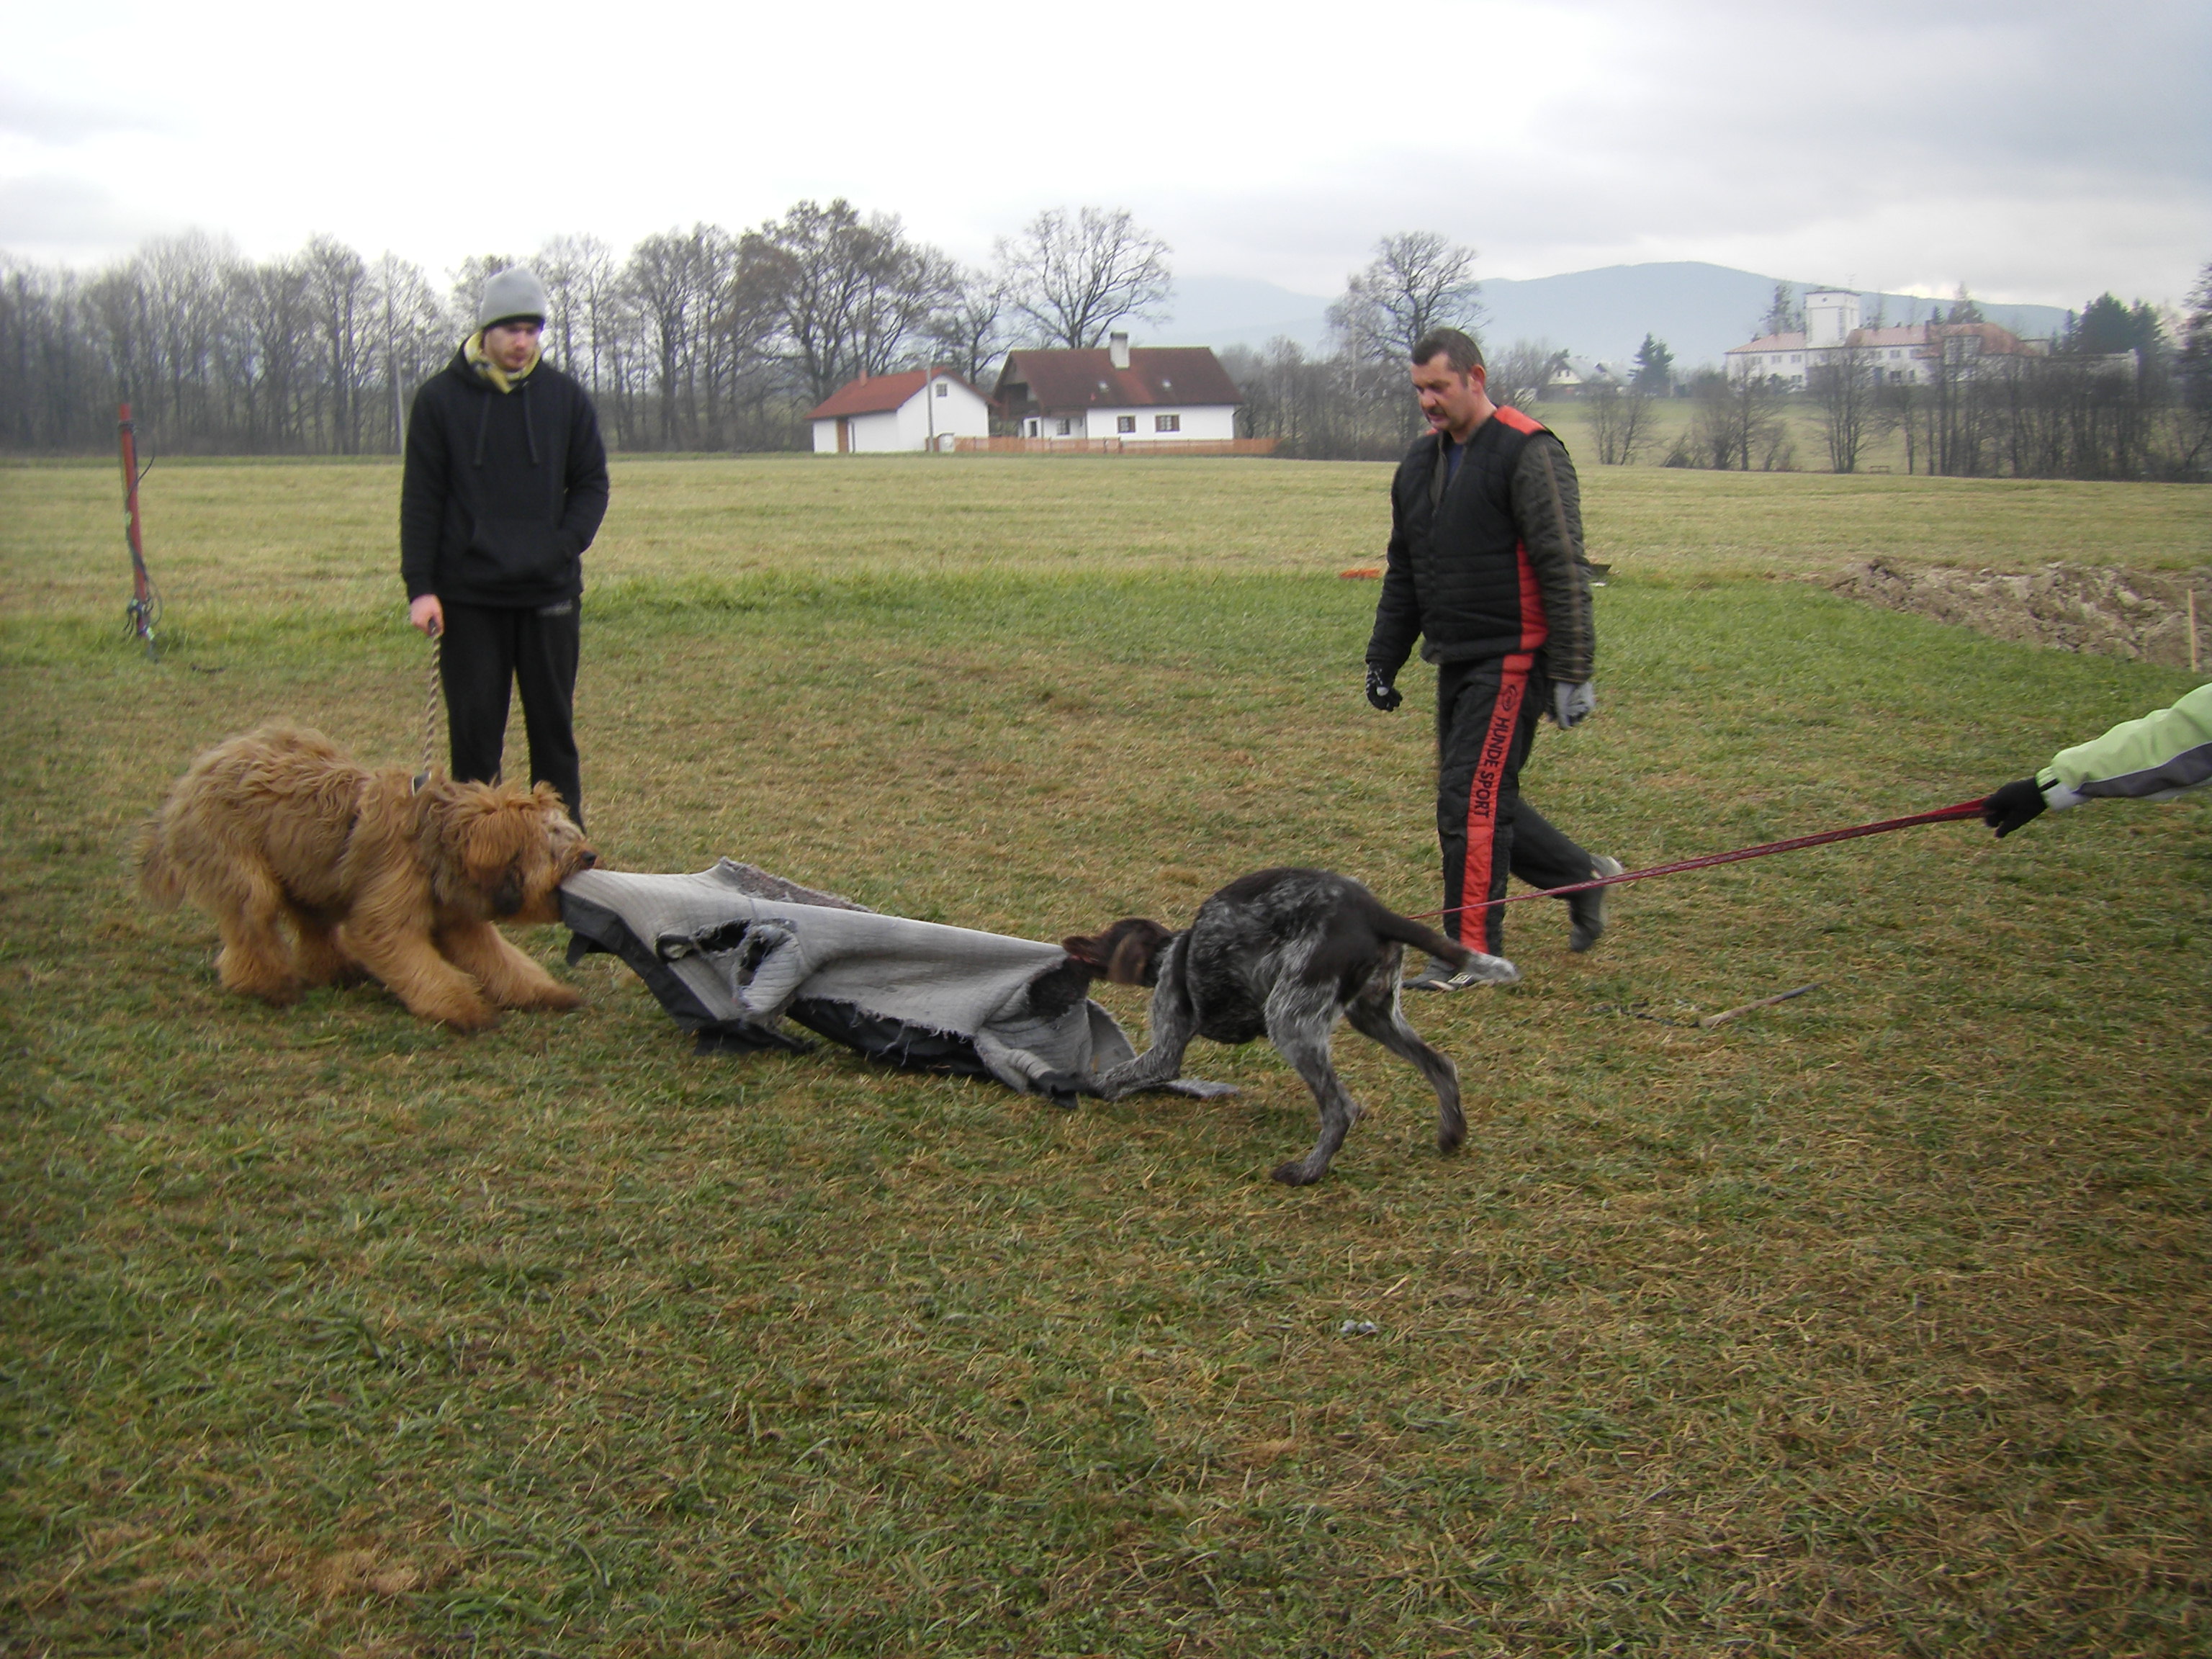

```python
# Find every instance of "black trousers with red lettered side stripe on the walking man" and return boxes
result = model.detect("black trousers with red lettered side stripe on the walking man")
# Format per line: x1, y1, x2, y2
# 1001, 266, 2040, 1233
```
1436, 650, 1593, 956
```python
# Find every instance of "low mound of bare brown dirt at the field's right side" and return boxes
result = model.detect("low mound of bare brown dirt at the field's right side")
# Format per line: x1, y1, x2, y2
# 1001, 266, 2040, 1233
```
1830, 559, 2212, 668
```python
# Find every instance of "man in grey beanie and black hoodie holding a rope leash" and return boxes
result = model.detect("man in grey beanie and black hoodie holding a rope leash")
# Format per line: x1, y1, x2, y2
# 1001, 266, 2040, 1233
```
400, 266, 606, 825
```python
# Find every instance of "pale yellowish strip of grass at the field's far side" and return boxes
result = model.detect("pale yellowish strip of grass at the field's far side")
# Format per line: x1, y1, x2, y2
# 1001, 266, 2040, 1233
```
0, 457, 2212, 619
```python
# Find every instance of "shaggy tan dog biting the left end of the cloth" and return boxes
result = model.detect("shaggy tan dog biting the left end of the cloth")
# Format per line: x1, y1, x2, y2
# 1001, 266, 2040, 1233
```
140, 726, 600, 1031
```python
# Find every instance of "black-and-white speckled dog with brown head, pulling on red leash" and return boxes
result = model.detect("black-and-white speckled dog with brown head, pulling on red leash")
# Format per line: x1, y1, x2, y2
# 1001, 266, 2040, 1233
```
1062, 869, 1519, 1186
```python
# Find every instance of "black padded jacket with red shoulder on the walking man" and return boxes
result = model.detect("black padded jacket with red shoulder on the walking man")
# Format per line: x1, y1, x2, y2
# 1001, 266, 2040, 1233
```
1367, 407, 1597, 683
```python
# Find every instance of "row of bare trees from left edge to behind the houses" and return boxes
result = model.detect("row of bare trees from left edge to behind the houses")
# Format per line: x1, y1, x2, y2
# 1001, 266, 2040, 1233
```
0, 199, 1170, 456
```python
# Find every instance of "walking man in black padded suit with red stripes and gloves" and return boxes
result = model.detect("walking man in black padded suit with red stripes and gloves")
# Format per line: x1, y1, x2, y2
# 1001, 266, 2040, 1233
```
1367, 328, 1622, 991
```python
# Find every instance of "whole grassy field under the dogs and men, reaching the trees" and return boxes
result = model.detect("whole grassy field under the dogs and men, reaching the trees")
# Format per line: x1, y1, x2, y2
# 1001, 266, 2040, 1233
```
0, 460, 2212, 1659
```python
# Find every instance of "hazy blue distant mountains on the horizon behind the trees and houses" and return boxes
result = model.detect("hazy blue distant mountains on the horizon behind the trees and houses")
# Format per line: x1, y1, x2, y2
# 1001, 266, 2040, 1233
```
1133, 261, 2066, 369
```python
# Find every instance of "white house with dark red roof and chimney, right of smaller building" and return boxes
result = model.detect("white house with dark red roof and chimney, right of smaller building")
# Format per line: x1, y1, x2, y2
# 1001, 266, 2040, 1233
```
995, 334, 1243, 444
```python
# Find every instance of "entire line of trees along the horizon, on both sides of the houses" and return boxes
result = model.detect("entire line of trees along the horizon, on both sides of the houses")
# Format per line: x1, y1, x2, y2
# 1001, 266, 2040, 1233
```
0, 199, 2212, 478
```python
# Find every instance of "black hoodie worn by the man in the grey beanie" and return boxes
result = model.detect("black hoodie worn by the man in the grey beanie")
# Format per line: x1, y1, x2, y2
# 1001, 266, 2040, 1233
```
400, 347, 606, 608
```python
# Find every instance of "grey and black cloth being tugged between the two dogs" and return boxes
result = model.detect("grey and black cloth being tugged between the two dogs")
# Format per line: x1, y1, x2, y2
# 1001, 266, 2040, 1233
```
562, 858, 1234, 1106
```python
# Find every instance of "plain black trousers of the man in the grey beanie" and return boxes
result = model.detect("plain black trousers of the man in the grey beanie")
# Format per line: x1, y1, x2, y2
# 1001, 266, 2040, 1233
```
438, 600, 584, 825
